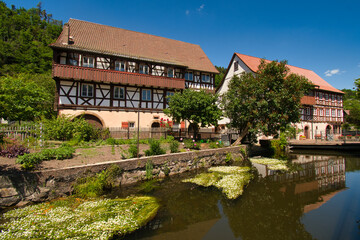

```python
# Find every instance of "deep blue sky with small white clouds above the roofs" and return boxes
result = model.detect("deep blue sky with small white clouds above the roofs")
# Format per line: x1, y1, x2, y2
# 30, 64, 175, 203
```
4, 0, 360, 89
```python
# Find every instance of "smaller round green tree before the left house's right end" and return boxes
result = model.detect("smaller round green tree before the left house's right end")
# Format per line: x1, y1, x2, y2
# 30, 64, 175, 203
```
164, 89, 222, 138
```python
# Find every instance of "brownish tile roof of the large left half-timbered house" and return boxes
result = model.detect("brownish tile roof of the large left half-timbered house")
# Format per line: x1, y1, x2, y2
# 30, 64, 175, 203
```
50, 19, 218, 73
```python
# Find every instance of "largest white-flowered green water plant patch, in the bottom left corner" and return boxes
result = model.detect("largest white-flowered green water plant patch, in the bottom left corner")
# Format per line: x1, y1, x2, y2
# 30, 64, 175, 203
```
0, 197, 160, 239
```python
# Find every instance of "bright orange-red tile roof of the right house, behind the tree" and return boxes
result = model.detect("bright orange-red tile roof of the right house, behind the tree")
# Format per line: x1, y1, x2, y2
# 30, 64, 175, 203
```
235, 53, 344, 94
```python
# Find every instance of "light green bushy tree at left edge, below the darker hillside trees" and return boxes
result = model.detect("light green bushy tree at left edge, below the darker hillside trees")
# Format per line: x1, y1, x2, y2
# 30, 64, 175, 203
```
0, 74, 55, 121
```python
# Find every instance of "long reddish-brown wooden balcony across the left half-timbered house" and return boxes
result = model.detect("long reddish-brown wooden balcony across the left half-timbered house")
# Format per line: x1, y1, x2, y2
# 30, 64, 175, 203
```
52, 64, 185, 89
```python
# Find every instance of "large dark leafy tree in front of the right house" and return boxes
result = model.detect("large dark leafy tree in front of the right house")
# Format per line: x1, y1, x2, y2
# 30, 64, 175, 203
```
222, 60, 312, 144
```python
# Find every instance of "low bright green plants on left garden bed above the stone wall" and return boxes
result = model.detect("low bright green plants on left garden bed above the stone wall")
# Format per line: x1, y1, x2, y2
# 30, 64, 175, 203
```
16, 145, 75, 170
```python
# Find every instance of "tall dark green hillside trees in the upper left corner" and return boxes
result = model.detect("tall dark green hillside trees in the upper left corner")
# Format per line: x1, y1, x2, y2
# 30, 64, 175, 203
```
0, 1, 62, 76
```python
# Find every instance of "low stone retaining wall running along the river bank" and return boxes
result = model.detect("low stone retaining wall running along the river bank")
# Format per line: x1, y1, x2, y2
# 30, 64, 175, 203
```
0, 146, 246, 207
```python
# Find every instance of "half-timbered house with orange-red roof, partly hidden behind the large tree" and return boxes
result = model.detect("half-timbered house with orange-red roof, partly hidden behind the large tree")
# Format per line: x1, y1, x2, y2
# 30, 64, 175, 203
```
217, 53, 344, 139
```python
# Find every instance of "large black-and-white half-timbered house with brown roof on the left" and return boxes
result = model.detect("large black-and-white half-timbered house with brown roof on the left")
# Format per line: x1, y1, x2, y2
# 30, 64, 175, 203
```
50, 19, 218, 128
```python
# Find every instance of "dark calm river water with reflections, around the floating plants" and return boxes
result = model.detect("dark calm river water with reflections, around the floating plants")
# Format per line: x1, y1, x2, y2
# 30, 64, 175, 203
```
113, 151, 360, 240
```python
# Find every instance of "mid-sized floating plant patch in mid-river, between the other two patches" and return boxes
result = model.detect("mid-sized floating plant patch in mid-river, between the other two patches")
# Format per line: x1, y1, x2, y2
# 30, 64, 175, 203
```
183, 166, 254, 199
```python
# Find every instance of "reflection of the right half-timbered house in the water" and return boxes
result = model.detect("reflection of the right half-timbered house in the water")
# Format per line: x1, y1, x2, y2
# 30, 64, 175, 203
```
253, 155, 345, 212
